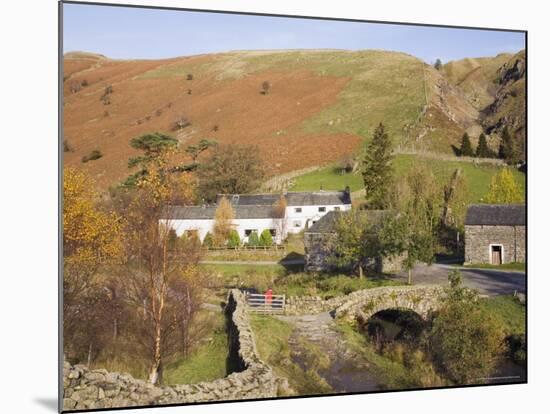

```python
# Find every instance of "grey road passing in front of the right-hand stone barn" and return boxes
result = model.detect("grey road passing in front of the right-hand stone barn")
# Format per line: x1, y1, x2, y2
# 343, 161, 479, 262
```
396, 263, 526, 296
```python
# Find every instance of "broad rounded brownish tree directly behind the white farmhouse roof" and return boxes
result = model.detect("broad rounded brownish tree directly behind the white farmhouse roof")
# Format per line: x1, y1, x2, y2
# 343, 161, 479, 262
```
197, 144, 264, 202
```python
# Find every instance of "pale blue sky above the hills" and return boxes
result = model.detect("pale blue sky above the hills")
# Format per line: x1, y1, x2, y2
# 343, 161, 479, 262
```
63, 4, 525, 63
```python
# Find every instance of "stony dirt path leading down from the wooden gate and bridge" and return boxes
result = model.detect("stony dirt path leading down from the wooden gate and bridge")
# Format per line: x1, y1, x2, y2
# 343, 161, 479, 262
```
277, 312, 380, 393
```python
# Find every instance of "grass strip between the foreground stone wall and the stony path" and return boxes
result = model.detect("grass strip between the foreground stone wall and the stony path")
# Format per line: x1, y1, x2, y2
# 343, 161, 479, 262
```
250, 315, 332, 395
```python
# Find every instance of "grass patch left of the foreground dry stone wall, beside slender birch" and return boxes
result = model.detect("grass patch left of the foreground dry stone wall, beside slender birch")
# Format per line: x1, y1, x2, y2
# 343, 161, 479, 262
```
164, 311, 228, 384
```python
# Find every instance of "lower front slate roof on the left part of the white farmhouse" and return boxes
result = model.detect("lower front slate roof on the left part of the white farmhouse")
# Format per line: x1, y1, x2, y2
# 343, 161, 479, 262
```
162, 205, 274, 220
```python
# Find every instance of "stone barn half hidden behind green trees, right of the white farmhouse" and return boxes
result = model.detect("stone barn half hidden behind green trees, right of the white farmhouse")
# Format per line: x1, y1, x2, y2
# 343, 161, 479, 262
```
304, 210, 403, 273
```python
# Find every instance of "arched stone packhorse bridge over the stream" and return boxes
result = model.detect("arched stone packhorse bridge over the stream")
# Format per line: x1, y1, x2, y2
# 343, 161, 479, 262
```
285, 285, 445, 320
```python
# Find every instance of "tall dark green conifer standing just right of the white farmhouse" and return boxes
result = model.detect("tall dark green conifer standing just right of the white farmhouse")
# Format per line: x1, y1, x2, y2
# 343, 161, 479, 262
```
363, 123, 393, 209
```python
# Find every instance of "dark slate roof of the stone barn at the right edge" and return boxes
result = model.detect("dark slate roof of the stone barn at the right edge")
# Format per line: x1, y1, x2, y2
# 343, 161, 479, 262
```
464, 204, 526, 226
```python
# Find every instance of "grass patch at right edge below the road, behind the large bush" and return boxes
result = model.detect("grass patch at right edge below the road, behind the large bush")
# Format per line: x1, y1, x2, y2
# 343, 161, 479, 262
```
481, 295, 526, 335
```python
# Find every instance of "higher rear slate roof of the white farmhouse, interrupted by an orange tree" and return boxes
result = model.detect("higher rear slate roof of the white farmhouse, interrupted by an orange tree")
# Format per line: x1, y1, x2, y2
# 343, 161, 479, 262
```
216, 191, 351, 206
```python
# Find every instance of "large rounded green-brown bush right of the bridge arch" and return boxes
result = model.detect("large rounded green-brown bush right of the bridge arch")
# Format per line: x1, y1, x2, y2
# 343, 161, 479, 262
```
430, 270, 505, 385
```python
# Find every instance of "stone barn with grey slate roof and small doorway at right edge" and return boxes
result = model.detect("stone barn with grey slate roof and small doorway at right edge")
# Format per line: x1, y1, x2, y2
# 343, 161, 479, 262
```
464, 204, 526, 265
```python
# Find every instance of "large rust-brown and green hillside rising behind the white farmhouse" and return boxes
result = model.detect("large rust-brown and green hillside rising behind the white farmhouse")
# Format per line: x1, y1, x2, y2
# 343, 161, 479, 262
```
63, 50, 528, 188
